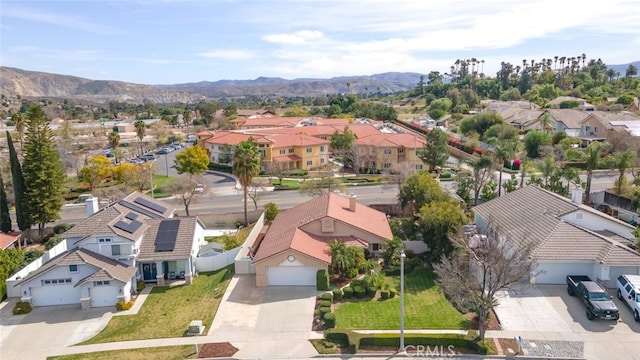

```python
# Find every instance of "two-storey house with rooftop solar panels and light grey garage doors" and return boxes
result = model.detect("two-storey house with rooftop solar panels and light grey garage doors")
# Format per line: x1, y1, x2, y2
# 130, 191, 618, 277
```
13, 192, 204, 309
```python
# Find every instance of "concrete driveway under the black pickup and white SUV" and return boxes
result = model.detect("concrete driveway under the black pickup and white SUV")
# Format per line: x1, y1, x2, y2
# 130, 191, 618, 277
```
496, 285, 640, 360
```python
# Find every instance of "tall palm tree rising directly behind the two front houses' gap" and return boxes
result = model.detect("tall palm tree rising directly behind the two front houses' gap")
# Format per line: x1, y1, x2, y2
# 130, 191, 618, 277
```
232, 138, 260, 226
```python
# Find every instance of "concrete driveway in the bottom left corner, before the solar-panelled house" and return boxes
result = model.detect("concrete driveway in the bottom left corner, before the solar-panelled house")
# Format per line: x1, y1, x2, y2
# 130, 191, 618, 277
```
0, 299, 112, 360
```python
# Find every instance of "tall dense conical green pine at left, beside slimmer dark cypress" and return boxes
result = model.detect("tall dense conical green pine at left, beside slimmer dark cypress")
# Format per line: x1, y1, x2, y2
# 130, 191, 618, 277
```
22, 106, 65, 239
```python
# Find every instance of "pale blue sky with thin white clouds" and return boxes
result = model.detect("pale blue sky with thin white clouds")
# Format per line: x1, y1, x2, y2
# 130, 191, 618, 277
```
0, 0, 640, 84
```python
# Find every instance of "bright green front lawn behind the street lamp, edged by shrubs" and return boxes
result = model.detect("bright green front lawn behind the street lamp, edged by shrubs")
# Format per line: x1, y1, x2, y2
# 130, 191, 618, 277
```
335, 268, 469, 330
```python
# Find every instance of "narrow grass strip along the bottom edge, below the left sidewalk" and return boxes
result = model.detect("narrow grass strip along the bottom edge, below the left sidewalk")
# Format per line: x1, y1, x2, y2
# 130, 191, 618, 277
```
47, 345, 198, 360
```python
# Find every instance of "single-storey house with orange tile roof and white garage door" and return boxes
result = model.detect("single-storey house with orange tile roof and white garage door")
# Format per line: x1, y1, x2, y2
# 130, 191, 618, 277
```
253, 193, 392, 287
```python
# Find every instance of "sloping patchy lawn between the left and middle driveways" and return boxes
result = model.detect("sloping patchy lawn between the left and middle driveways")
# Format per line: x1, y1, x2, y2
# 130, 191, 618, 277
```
81, 265, 233, 345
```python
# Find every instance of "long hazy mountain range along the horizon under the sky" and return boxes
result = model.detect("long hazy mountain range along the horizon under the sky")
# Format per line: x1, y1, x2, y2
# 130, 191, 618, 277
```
0, 67, 420, 103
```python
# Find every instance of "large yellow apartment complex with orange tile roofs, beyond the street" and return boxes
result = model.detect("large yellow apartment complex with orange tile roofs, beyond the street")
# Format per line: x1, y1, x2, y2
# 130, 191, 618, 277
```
197, 118, 425, 172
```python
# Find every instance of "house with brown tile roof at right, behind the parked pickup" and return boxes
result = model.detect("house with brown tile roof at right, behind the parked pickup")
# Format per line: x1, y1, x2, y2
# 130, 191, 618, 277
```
472, 185, 640, 287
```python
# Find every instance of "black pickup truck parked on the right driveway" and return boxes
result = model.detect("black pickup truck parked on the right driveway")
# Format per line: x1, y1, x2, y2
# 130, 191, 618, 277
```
567, 275, 620, 321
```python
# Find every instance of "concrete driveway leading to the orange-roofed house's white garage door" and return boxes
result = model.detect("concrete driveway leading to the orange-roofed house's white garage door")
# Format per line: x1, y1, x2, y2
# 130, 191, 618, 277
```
208, 275, 318, 359
